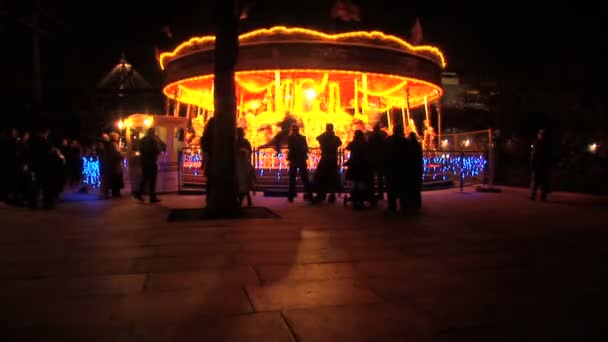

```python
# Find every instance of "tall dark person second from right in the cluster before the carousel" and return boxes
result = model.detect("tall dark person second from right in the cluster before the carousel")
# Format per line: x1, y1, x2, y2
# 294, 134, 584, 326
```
385, 124, 411, 211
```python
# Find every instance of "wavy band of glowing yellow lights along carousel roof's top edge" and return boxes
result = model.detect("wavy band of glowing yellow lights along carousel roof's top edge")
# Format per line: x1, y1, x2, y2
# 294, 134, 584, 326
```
159, 26, 446, 69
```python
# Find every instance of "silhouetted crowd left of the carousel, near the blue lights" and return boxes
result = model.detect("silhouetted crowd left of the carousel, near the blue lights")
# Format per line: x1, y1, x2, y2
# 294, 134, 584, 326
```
0, 128, 162, 209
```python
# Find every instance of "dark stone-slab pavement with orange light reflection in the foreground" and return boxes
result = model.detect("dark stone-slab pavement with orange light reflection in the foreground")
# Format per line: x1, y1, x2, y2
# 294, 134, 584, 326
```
0, 189, 608, 342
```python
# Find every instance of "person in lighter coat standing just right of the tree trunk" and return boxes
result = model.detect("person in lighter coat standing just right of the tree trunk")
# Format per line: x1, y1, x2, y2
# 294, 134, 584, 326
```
235, 128, 255, 207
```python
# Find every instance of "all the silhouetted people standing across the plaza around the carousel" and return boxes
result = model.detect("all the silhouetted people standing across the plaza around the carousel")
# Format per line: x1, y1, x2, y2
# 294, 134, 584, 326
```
0, 119, 552, 211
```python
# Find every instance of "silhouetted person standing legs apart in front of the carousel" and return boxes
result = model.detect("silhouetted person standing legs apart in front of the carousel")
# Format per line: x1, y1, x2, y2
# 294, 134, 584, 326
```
287, 125, 312, 202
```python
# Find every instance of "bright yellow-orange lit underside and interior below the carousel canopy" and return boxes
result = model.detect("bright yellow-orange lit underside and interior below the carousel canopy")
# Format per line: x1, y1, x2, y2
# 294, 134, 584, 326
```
163, 69, 442, 147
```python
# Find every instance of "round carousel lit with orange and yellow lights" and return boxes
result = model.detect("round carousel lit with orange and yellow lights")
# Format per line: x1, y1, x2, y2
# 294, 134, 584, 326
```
159, 26, 486, 192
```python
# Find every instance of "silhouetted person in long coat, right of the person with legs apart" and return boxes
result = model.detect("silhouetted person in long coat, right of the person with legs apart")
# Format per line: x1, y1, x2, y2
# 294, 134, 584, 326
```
315, 124, 342, 202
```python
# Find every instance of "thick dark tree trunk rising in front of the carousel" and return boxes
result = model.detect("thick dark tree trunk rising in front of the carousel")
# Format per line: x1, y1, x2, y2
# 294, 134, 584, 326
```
207, 0, 238, 216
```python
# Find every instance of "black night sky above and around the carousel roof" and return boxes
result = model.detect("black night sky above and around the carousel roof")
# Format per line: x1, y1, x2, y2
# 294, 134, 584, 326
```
0, 0, 607, 120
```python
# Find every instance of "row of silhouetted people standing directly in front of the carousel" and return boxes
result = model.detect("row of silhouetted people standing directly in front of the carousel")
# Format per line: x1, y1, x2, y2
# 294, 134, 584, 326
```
201, 118, 423, 211
